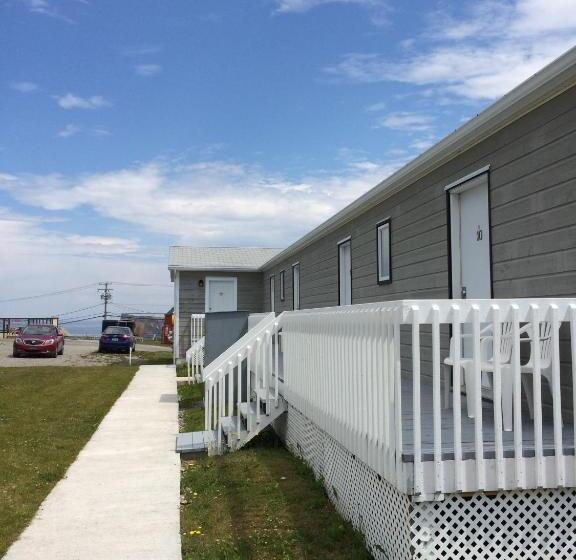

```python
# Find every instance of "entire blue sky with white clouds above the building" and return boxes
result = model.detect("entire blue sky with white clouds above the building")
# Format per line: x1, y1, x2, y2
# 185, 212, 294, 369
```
0, 0, 576, 319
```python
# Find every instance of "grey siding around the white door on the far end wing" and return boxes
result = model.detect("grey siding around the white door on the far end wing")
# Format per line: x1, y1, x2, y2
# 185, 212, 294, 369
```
179, 272, 263, 358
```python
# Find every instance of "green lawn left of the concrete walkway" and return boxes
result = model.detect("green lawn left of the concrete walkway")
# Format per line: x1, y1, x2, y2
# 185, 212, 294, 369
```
0, 365, 137, 557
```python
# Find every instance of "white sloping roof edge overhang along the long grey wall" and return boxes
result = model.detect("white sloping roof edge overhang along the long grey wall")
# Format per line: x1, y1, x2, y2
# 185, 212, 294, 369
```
260, 47, 576, 270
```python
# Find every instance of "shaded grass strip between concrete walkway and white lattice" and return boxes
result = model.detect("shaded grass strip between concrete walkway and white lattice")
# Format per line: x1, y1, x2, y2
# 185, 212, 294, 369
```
178, 385, 371, 560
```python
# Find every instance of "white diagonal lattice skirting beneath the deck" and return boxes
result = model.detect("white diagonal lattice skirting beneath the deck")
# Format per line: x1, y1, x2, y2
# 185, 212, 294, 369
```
275, 406, 576, 560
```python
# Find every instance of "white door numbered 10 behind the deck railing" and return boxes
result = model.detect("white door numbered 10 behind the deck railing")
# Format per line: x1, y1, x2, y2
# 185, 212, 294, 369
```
450, 173, 492, 299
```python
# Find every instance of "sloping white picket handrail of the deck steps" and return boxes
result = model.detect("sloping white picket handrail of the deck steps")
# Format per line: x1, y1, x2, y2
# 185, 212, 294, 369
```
203, 313, 281, 450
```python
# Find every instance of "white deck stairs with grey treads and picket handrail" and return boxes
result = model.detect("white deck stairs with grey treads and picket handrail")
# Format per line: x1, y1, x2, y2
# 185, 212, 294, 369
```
176, 313, 287, 454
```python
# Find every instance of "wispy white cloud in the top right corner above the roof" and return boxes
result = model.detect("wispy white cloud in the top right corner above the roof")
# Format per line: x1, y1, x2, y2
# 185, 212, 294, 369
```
327, 0, 576, 100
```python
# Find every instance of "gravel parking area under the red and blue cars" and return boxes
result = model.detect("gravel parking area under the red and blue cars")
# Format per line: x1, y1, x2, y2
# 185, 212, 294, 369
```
0, 338, 172, 367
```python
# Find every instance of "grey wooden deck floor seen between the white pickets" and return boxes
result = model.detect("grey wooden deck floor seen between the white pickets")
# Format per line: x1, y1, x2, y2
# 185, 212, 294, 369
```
402, 376, 574, 463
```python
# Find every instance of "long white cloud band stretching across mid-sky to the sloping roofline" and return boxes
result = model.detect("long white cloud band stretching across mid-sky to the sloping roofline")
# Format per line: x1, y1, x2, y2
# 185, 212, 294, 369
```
0, 159, 404, 246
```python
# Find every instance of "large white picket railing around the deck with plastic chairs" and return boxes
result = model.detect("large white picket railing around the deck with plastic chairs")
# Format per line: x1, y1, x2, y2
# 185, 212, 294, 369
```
280, 299, 576, 499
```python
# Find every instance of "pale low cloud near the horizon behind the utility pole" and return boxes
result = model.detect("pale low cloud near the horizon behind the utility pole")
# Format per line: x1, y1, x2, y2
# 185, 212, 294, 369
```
0, 207, 172, 319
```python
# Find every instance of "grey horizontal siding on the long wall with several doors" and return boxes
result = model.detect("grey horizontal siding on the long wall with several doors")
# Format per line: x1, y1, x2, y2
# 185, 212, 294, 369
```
264, 83, 576, 312
